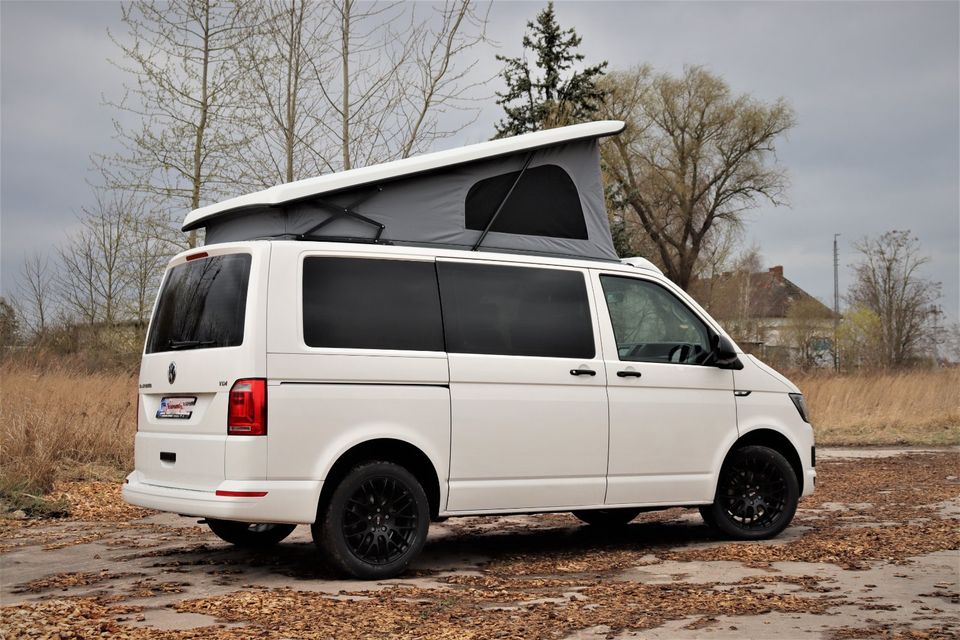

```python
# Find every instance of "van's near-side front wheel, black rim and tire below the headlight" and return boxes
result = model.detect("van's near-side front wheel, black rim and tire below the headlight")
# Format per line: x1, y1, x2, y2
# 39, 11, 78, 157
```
700, 446, 800, 540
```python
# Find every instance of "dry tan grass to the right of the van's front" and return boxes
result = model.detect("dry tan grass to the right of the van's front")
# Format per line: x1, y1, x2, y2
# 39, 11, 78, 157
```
792, 368, 960, 445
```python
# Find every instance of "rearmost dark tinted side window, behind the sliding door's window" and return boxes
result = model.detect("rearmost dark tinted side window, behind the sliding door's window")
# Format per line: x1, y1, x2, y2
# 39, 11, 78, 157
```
303, 257, 443, 351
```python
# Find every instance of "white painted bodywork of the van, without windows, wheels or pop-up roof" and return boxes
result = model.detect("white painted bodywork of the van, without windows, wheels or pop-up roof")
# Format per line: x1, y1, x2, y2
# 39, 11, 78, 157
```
124, 241, 815, 523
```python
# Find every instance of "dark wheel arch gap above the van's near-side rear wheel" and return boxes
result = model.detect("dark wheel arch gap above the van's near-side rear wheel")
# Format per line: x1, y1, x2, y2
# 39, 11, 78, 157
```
317, 438, 440, 519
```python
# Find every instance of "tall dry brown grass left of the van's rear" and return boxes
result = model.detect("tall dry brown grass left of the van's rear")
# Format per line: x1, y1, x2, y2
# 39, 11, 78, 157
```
0, 360, 137, 504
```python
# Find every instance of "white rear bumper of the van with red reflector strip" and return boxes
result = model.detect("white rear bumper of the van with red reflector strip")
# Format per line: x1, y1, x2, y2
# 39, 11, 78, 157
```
123, 471, 323, 524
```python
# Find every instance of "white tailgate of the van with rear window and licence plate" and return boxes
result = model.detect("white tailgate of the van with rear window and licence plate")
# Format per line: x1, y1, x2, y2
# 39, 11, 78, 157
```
136, 243, 269, 490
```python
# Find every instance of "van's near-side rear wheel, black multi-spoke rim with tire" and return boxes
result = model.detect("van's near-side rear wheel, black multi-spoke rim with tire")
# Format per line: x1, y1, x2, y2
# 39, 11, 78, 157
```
311, 462, 430, 580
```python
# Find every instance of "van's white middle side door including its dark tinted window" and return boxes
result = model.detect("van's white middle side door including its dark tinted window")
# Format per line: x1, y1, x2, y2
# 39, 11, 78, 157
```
437, 260, 607, 512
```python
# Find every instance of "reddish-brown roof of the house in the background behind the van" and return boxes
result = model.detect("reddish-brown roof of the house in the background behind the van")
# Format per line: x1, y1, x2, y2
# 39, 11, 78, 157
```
689, 266, 833, 320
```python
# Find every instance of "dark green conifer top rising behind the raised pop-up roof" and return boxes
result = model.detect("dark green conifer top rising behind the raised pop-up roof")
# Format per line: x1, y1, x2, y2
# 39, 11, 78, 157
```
496, 2, 607, 138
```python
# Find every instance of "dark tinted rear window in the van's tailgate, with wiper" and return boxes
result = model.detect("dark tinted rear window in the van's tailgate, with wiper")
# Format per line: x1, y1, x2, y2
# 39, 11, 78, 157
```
146, 253, 250, 353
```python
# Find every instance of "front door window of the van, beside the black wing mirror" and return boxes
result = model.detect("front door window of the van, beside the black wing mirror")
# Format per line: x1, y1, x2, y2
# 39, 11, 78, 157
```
600, 276, 710, 364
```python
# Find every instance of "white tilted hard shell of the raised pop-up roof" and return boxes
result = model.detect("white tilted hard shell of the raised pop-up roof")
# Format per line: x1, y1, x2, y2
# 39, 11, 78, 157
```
182, 120, 625, 231
